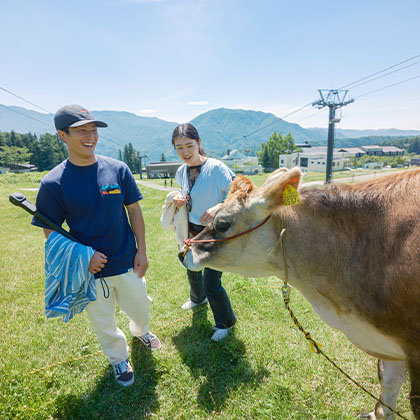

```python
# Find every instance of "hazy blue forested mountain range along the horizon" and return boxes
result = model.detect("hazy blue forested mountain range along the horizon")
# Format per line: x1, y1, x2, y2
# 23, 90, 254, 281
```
0, 105, 420, 162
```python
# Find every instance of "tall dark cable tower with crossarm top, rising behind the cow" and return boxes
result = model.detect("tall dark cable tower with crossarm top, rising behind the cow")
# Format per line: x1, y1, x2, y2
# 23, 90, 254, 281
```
312, 89, 354, 184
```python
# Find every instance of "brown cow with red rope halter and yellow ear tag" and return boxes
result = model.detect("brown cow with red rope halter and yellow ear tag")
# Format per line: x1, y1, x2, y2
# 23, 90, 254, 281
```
180, 168, 420, 420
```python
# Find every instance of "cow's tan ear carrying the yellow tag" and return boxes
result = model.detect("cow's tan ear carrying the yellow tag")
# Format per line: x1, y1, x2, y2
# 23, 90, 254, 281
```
259, 168, 302, 211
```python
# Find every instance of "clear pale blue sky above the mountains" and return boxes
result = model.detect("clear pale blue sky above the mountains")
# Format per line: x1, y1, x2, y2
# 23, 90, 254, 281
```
0, 0, 420, 129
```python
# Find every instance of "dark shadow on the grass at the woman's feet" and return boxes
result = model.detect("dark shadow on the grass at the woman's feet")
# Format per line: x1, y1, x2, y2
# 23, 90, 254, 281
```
172, 307, 269, 412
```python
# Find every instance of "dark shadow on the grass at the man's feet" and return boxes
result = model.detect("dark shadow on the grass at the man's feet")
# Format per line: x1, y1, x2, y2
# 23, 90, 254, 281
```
55, 339, 159, 420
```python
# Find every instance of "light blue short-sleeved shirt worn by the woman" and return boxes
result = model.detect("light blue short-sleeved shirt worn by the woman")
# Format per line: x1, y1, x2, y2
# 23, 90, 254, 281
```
175, 158, 235, 225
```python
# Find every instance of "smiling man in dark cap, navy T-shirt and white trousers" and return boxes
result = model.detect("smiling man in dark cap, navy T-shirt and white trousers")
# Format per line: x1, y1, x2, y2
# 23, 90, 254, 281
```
32, 105, 161, 386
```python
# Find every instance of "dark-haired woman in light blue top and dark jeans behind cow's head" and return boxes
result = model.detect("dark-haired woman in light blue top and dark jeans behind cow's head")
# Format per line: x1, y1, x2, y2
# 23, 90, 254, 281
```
172, 124, 236, 341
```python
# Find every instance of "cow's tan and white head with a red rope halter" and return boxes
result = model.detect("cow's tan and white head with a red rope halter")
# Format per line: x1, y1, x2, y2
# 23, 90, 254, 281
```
179, 168, 302, 277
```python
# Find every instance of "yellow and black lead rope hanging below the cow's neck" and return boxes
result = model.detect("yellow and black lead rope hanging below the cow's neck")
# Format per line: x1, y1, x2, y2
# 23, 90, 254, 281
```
280, 228, 409, 420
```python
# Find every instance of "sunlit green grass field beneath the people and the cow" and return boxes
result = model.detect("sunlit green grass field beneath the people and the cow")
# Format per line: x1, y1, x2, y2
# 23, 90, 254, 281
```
0, 174, 412, 420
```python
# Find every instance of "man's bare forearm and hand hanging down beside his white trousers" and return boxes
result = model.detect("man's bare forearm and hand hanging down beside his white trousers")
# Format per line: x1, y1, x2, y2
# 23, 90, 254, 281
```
126, 202, 149, 277
